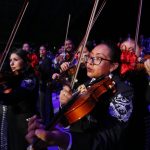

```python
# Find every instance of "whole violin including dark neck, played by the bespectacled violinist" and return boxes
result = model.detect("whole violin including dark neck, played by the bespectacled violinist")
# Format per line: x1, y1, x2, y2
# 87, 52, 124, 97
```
32, 77, 116, 149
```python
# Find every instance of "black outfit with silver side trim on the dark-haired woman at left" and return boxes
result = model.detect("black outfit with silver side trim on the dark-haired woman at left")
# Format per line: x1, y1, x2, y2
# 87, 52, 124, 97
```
0, 74, 38, 150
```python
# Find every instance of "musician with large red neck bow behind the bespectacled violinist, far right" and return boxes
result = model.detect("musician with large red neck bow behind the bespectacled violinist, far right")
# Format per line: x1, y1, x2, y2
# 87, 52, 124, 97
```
120, 35, 149, 149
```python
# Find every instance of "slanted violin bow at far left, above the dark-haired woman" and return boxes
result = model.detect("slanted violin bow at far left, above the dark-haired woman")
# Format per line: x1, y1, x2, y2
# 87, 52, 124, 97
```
0, 0, 29, 71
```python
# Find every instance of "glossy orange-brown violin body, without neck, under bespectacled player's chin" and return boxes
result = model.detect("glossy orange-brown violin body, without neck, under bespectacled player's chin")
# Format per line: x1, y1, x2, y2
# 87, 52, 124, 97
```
65, 77, 116, 124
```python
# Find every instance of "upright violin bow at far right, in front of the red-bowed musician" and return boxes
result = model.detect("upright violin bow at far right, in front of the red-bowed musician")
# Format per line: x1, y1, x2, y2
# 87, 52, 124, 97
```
135, 0, 143, 57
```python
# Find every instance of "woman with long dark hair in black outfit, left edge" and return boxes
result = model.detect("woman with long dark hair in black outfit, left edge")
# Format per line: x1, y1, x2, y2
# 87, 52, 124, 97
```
0, 49, 38, 150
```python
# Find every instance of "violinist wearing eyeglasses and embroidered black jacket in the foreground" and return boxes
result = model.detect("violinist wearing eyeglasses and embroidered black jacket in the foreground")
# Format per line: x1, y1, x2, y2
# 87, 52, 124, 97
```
26, 42, 133, 150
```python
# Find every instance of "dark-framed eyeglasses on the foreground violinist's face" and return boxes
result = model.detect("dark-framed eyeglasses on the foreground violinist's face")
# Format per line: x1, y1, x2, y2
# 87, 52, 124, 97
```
85, 56, 112, 65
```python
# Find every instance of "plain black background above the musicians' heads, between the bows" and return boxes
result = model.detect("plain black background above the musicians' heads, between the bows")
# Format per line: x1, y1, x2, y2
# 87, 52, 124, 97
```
0, 0, 150, 50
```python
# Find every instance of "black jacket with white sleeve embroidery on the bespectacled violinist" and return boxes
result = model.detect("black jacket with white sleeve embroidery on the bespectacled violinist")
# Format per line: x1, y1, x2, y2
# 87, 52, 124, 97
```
70, 76, 133, 150
